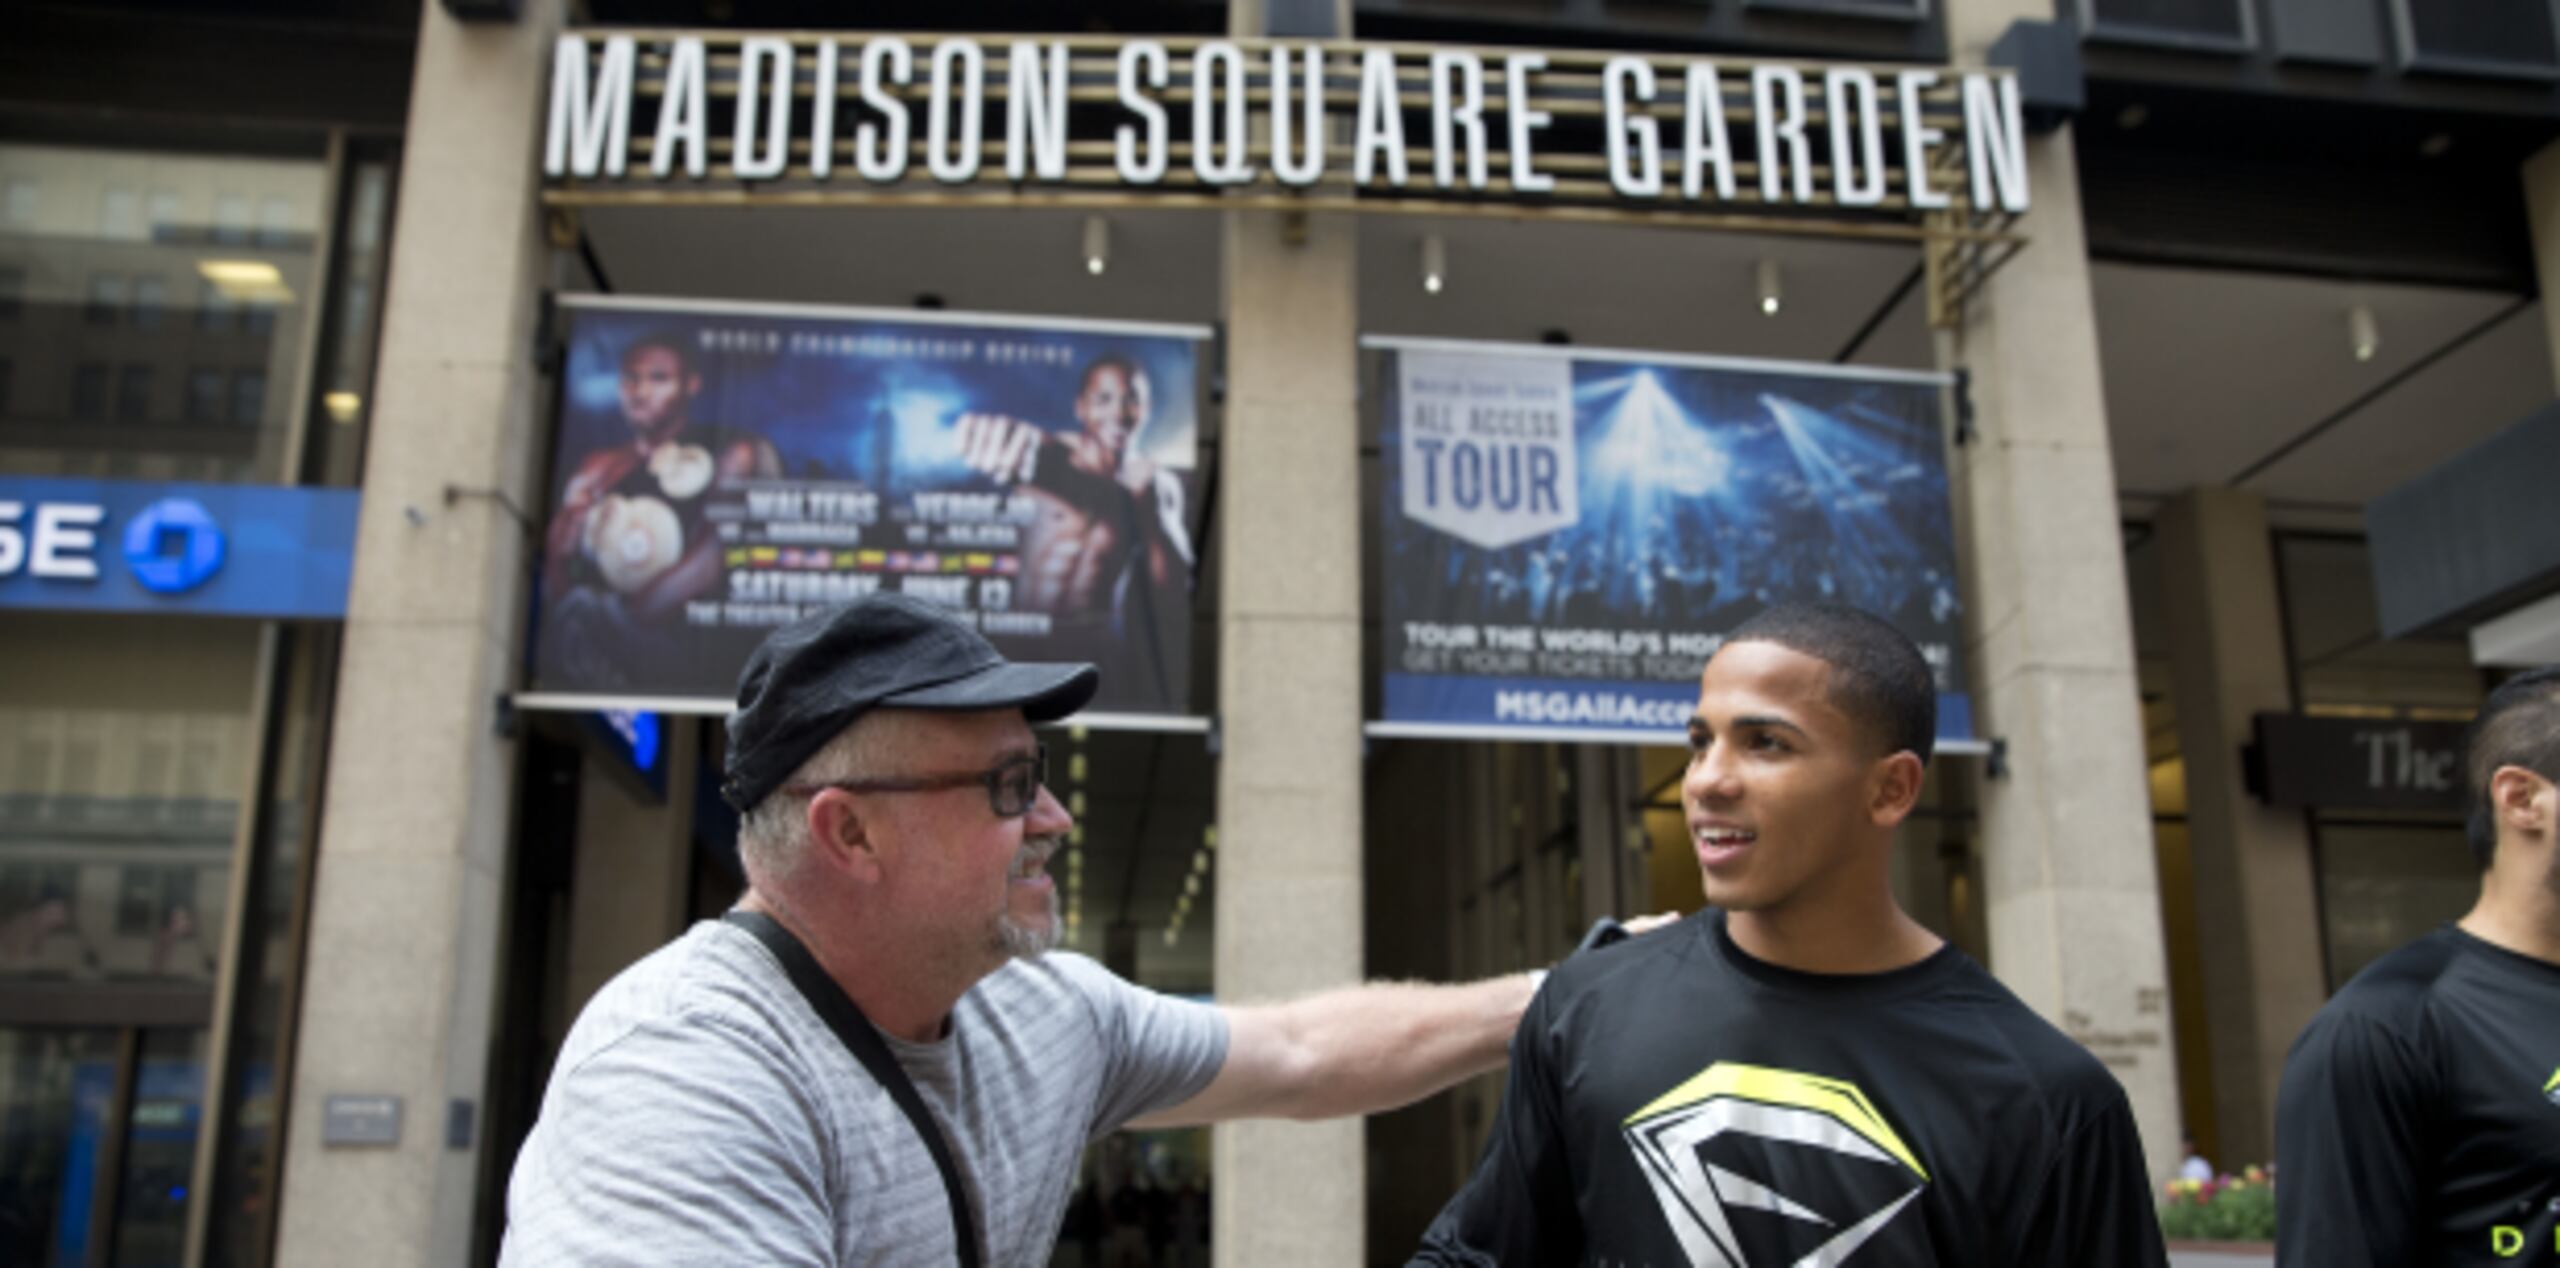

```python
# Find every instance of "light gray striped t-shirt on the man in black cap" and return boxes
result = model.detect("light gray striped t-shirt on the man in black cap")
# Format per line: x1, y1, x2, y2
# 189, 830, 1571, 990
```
499, 922, 1226, 1265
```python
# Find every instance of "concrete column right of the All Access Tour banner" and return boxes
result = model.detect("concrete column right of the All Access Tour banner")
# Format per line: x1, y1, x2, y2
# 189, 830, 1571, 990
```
1940, 0, 2179, 1176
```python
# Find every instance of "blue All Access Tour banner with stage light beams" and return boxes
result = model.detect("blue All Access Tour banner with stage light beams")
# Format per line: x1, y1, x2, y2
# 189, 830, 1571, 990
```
1364, 338, 1974, 743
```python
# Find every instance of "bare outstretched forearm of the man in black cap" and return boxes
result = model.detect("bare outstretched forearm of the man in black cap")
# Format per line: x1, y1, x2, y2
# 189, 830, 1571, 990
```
1132, 973, 1533, 1130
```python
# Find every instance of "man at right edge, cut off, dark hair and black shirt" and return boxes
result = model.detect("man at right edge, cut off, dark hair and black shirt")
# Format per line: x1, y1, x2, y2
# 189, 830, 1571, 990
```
2276, 669, 2560, 1268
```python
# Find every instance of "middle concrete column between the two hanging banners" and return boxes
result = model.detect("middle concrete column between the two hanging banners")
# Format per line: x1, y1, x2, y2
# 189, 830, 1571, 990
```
1213, 203, 1367, 1268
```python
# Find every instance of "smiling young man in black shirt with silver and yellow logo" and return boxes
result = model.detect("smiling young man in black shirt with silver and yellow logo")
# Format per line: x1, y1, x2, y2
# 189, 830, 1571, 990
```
1416, 605, 2166, 1268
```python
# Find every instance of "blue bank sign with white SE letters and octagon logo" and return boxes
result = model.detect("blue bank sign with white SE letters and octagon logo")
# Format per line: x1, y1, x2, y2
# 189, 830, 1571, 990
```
0, 479, 356, 620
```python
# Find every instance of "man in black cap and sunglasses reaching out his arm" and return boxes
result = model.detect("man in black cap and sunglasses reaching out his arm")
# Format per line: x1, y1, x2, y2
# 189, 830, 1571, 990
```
502, 594, 1566, 1265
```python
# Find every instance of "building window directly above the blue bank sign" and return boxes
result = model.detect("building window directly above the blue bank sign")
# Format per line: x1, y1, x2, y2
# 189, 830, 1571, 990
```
0, 138, 345, 491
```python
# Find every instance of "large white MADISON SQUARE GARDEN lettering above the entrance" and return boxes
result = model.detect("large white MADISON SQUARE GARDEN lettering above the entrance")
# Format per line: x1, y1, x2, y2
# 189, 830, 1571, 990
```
543, 33, 2028, 215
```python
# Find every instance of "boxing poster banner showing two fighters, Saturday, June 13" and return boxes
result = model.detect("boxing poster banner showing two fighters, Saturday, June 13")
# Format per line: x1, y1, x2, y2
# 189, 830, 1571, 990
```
532, 297, 1211, 715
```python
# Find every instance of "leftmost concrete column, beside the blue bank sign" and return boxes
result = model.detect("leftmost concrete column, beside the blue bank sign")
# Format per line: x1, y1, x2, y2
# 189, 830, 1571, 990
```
276, 0, 561, 1268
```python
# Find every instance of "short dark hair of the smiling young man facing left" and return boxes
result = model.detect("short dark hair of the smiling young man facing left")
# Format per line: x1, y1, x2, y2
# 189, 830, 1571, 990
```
1725, 602, 1938, 766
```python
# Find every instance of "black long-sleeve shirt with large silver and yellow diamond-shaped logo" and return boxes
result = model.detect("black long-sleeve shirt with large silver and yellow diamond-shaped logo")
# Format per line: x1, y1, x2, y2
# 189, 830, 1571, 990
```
1416, 912, 2166, 1268
